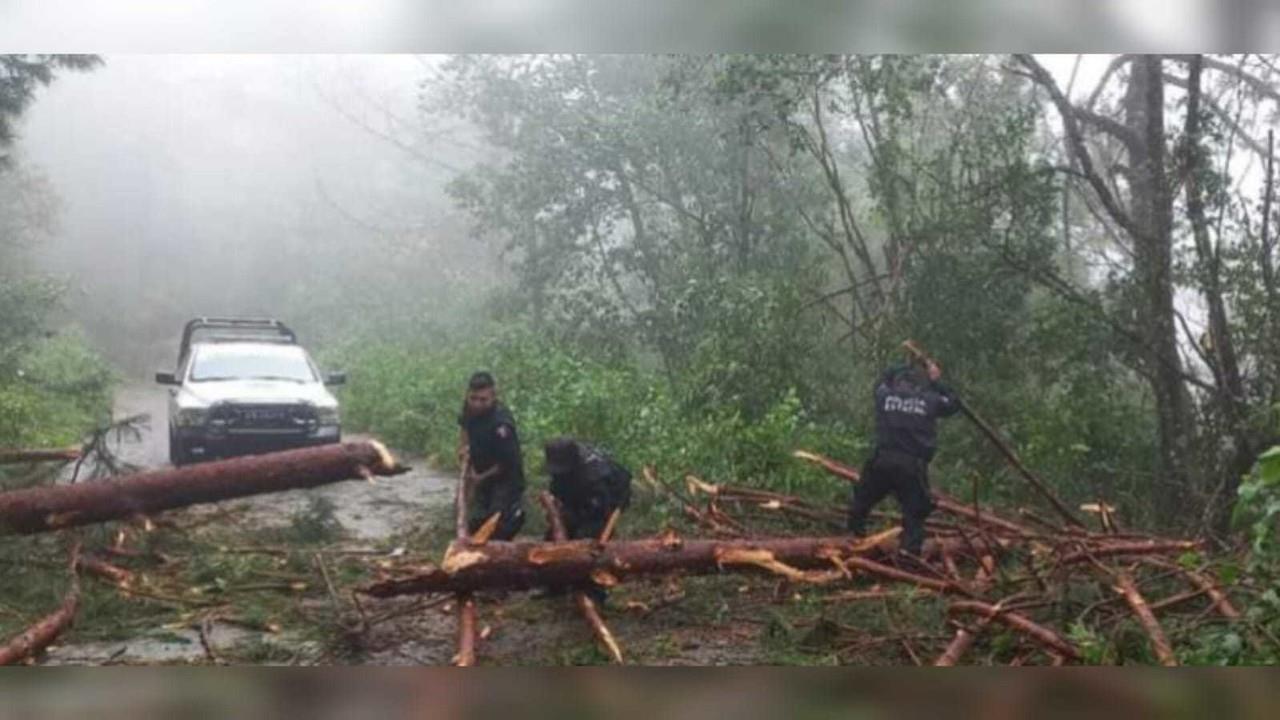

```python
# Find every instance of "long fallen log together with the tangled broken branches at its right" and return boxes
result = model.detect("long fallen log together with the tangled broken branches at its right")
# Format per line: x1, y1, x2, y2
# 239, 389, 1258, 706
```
360, 452, 1242, 666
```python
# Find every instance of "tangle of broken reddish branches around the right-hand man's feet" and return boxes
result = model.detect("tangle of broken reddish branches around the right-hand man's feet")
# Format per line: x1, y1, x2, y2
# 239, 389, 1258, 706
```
678, 451, 1242, 666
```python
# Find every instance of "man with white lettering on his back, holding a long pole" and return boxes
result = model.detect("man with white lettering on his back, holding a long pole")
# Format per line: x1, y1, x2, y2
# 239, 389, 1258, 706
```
849, 361, 960, 557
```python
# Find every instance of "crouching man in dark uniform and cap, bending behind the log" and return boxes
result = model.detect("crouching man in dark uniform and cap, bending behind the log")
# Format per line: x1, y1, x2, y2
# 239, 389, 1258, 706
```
544, 437, 631, 603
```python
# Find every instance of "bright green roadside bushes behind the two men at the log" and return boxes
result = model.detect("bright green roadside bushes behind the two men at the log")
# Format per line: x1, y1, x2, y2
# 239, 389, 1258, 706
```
333, 320, 864, 509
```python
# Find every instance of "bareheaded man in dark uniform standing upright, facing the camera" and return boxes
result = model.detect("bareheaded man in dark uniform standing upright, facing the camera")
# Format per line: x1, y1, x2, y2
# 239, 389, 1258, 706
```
458, 372, 525, 541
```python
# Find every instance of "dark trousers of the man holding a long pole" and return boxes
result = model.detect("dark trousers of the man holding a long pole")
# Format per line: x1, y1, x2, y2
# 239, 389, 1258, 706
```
849, 451, 933, 555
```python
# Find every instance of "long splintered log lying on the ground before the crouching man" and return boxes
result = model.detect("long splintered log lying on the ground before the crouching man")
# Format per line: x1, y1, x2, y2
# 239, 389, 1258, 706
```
362, 534, 1000, 597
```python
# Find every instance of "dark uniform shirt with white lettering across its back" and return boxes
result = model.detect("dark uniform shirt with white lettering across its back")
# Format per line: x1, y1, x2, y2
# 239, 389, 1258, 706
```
876, 366, 960, 462
